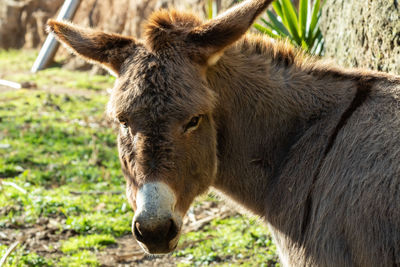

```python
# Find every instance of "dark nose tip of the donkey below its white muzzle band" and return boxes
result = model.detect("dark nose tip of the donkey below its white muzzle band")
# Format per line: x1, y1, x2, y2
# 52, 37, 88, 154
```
132, 216, 180, 254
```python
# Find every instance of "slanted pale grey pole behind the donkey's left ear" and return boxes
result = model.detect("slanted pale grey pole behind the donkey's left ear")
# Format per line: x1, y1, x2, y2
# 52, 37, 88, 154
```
31, 0, 80, 73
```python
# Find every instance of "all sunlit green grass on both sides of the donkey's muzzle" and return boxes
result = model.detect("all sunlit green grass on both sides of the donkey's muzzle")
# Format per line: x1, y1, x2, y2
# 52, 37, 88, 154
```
0, 50, 276, 266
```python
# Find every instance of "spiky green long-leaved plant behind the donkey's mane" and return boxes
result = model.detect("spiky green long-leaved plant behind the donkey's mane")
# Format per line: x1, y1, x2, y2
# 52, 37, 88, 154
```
254, 0, 324, 55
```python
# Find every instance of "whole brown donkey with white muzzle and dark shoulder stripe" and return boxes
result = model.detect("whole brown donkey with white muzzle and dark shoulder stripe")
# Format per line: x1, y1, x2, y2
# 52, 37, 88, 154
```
48, 0, 400, 266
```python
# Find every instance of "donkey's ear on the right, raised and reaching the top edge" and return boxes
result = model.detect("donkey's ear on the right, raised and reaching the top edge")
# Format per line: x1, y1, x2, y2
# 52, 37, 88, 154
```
187, 0, 273, 63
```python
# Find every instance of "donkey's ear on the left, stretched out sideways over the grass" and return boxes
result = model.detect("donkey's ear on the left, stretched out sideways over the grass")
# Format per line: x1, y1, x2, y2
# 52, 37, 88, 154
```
47, 20, 136, 74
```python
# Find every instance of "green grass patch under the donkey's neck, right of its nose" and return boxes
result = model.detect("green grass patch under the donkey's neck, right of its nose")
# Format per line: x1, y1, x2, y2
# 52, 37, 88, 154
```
174, 216, 277, 267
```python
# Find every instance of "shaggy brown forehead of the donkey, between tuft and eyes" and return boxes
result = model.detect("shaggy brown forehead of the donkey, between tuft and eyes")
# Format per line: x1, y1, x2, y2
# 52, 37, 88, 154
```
108, 49, 216, 124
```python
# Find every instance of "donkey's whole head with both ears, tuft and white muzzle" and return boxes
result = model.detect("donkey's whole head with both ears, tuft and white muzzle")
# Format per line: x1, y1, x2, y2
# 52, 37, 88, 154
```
48, 1, 270, 253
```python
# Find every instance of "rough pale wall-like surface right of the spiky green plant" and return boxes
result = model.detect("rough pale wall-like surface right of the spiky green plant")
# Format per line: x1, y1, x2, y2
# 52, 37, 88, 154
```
321, 0, 400, 74
